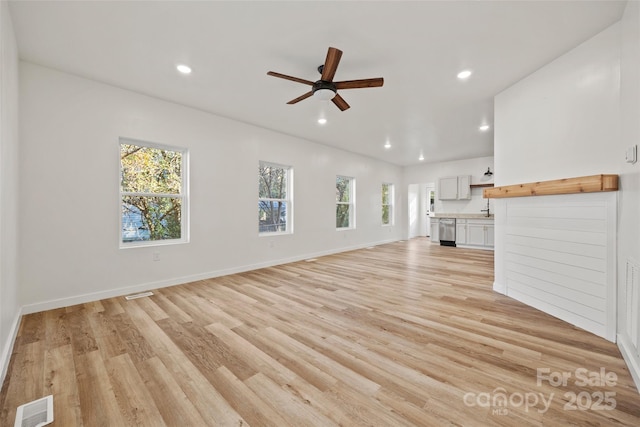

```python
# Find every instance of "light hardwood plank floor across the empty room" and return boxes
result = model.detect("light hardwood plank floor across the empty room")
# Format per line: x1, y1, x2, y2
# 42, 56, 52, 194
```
0, 238, 640, 427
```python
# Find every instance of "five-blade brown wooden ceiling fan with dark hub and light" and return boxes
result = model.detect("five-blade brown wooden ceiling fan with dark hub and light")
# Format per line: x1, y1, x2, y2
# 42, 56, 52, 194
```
267, 47, 384, 111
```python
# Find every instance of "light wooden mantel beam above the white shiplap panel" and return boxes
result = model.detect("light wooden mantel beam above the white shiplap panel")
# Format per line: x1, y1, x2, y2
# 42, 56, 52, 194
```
483, 175, 618, 199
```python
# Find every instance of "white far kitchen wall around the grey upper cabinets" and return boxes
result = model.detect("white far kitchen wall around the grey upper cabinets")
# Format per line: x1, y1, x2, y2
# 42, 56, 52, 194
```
404, 157, 493, 214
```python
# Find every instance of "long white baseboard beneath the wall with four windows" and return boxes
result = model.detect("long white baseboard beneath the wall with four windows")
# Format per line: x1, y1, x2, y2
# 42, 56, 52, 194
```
22, 239, 397, 314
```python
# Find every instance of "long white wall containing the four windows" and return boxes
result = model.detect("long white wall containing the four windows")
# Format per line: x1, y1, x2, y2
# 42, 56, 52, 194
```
19, 62, 406, 312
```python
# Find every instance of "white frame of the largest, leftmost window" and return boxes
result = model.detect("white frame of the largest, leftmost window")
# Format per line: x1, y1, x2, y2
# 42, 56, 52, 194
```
118, 137, 190, 249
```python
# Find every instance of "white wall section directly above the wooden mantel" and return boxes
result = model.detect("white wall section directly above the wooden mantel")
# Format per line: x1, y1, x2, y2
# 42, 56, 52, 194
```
494, 24, 624, 186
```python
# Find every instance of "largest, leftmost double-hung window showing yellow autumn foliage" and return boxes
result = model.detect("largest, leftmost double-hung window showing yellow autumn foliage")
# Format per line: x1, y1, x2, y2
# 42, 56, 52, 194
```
120, 139, 188, 247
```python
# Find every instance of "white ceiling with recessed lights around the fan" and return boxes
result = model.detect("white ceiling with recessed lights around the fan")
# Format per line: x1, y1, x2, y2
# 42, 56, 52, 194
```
10, 0, 625, 165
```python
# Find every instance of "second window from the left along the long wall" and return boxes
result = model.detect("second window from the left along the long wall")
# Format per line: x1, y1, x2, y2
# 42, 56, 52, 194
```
258, 162, 293, 233
